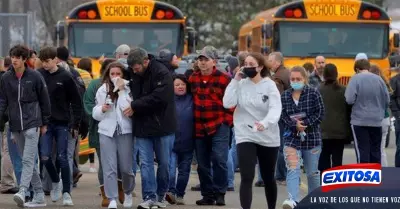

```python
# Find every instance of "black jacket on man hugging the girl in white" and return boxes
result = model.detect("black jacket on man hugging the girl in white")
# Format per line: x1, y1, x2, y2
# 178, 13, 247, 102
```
130, 55, 176, 138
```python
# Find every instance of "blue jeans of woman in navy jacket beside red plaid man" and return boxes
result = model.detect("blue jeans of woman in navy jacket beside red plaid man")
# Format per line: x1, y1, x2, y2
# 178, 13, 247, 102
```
169, 152, 193, 197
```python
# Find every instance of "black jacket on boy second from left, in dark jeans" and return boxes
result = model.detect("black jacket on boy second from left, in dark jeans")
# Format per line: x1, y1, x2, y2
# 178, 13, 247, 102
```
38, 67, 83, 129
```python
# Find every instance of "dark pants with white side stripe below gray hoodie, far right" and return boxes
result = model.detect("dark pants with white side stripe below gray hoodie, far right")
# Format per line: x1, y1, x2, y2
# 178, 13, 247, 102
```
351, 125, 382, 163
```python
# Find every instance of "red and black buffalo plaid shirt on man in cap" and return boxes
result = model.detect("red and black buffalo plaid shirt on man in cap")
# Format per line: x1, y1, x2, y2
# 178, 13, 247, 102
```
189, 68, 233, 137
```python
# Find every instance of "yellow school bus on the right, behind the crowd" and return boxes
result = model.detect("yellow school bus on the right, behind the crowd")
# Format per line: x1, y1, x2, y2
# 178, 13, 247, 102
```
238, 0, 399, 85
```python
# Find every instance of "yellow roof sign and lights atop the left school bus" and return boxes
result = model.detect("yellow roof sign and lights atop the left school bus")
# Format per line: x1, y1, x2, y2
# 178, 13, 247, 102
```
66, 0, 185, 22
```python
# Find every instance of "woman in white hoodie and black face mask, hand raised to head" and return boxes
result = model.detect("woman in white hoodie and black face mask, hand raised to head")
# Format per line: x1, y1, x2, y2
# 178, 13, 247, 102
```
223, 53, 282, 209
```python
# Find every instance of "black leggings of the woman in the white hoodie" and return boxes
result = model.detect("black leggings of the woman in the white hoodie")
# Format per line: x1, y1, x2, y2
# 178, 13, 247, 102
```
237, 142, 279, 209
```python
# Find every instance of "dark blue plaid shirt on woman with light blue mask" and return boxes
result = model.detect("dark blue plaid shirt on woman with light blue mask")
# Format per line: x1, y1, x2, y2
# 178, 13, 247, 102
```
281, 85, 325, 150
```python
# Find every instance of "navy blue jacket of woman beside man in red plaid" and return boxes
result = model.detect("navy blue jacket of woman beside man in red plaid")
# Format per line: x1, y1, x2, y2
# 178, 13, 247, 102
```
173, 94, 194, 152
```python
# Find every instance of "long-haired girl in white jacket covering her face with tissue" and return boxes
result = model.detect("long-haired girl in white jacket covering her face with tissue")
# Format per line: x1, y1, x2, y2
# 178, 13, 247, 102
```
92, 62, 135, 208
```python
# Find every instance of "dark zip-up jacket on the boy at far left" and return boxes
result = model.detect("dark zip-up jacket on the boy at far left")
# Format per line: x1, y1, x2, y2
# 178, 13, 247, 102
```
0, 65, 51, 132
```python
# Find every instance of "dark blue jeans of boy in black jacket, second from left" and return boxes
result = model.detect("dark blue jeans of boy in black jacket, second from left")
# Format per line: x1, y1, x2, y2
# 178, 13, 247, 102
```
40, 124, 71, 193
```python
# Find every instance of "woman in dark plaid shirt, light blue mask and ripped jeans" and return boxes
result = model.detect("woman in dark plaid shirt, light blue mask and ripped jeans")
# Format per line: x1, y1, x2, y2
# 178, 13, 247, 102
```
281, 66, 325, 209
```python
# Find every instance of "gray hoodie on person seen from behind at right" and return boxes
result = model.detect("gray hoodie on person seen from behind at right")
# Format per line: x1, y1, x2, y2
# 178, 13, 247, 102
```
345, 72, 390, 127
